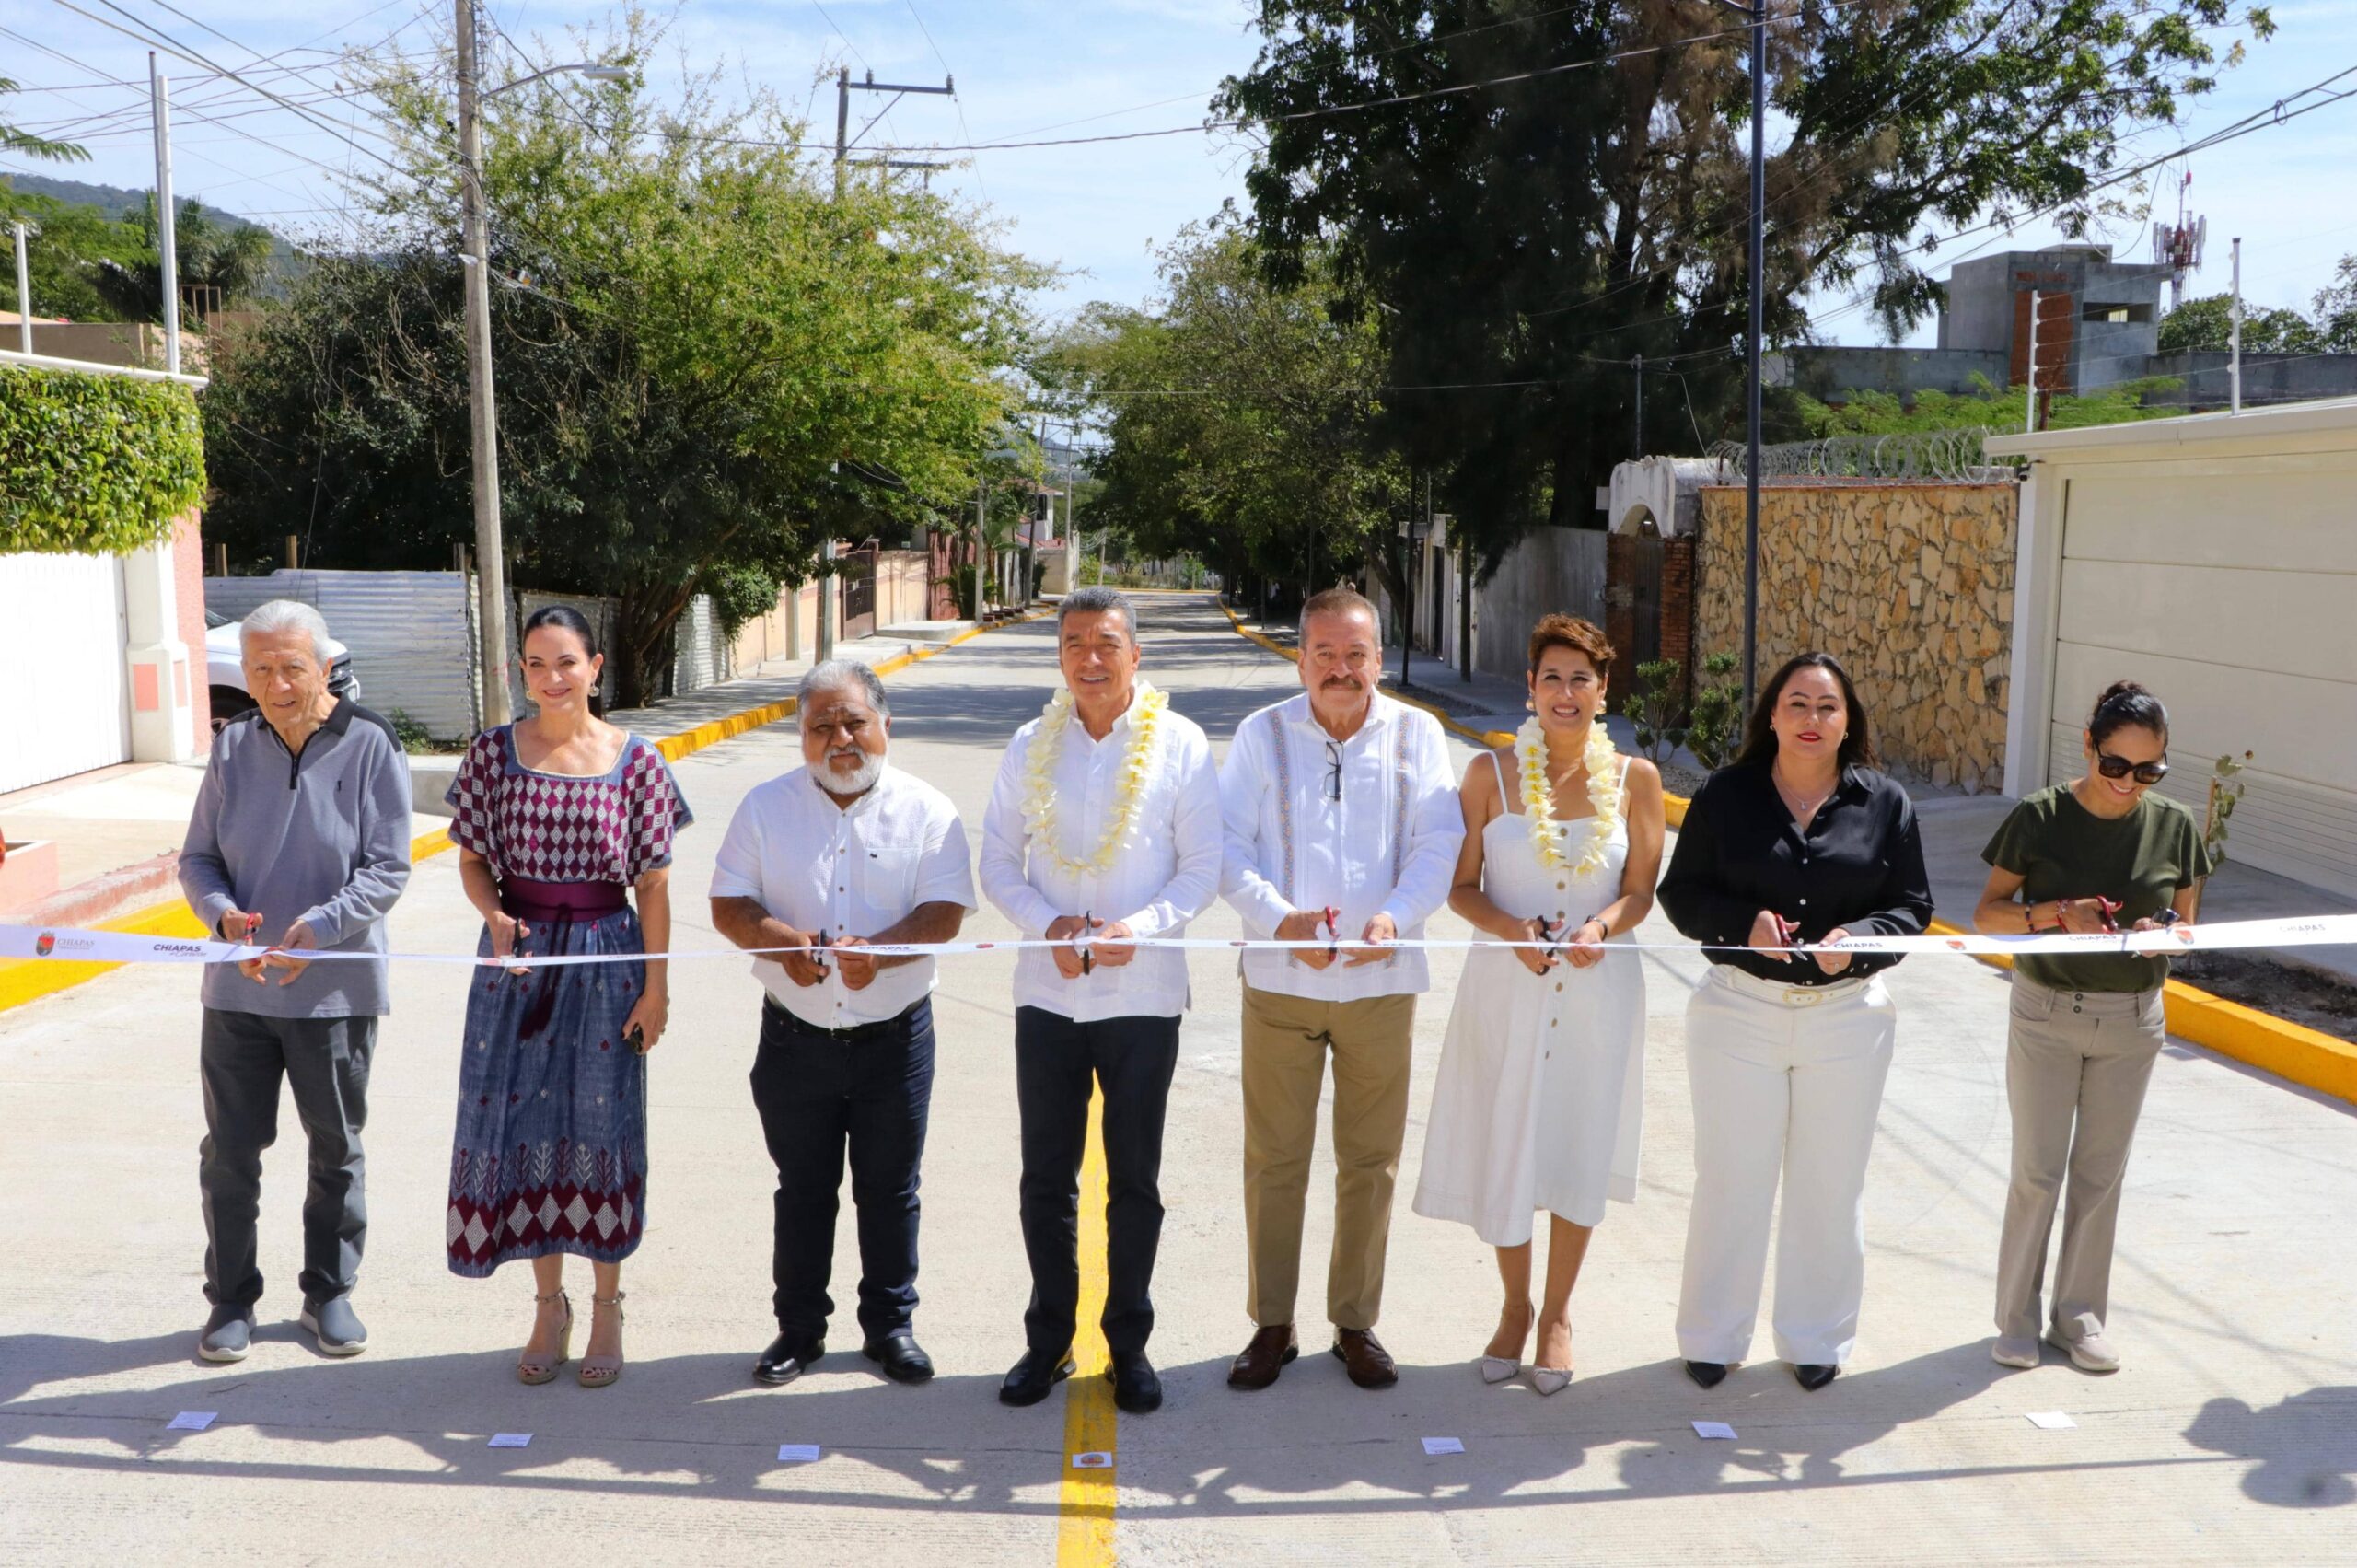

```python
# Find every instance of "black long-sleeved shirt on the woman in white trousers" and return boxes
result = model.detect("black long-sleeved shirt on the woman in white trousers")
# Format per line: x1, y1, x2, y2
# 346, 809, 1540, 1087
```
1659, 764, 1931, 985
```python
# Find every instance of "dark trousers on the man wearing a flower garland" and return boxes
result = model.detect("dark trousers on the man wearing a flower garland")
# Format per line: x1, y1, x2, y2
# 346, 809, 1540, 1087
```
1016, 1007, 1178, 1353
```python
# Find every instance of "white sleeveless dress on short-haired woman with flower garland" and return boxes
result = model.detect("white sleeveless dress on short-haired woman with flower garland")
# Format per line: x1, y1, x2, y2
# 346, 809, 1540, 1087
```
1414, 752, 1645, 1248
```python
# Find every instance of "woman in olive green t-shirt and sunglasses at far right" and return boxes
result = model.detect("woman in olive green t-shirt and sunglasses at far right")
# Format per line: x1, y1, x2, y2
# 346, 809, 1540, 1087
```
1973, 681, 2211, 1372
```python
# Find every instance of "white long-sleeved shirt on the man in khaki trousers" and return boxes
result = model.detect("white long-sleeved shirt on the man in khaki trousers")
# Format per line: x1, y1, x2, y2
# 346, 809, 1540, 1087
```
1219, 693, 1464, 1002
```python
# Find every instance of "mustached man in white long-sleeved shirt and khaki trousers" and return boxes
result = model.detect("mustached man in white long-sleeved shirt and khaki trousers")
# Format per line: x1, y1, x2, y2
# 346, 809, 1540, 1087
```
1219, 587, 1464, 1388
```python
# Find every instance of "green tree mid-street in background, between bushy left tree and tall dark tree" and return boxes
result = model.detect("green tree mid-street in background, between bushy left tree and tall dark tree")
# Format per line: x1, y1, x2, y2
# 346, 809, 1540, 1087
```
1037, 222, 1410, 622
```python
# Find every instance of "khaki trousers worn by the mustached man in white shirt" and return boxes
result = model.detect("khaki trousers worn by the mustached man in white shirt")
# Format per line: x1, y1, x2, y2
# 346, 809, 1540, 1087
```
1245, 985, 1417, 1328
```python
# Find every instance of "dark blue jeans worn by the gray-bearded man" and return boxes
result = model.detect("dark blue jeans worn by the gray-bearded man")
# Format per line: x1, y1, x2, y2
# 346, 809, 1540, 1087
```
752, 1000, 934, 1340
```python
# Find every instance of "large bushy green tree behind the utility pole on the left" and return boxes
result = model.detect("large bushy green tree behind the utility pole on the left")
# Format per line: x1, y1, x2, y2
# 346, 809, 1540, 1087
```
207, 14, 1044, 701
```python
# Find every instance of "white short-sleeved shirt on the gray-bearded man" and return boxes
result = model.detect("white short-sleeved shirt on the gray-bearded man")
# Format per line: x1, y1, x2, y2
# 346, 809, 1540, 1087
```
712, 766, 973, 1028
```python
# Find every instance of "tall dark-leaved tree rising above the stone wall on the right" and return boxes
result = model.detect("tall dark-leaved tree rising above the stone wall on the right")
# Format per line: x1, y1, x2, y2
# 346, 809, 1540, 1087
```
1219, 0, 2272, 563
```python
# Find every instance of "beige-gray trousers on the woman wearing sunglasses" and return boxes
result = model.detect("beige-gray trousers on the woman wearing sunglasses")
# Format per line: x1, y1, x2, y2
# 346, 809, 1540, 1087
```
1996, 974, 2168, 1340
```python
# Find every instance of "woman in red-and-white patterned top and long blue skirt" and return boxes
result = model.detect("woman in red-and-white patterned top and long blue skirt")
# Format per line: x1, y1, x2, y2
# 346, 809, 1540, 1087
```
446, 606, 693, 1388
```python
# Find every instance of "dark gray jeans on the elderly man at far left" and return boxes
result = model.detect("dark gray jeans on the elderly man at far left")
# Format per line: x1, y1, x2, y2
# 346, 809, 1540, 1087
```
195, 1007, 377, 1307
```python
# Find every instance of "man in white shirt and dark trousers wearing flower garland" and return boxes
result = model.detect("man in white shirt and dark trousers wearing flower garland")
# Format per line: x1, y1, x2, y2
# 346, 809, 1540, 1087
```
981, 587, 1221, 1415
